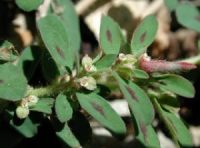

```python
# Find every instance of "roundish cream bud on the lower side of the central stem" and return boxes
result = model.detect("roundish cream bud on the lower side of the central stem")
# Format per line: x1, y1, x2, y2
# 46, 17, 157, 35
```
79, 76, 97, 90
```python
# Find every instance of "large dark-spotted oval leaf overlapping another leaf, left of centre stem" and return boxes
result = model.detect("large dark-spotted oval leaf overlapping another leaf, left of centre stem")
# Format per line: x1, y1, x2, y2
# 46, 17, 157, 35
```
38, 14, 75, 69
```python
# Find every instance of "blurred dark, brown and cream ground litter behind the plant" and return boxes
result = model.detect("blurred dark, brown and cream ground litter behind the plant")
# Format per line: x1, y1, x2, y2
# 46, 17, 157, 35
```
0, 0, 200, 148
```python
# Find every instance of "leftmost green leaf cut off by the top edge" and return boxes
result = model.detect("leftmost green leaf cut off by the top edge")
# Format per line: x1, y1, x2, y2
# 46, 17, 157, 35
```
15, 0, 44, 12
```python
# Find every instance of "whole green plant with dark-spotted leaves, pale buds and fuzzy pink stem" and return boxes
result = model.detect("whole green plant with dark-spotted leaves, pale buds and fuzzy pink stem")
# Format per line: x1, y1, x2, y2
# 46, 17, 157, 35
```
0, 0, 196, 147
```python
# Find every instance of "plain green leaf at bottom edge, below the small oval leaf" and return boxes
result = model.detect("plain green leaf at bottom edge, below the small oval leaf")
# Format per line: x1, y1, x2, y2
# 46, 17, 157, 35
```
56, 124, 80, 148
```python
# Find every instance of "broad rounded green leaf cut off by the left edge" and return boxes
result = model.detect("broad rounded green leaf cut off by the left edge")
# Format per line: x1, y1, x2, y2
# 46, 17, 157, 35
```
0, 63, 27, 101
